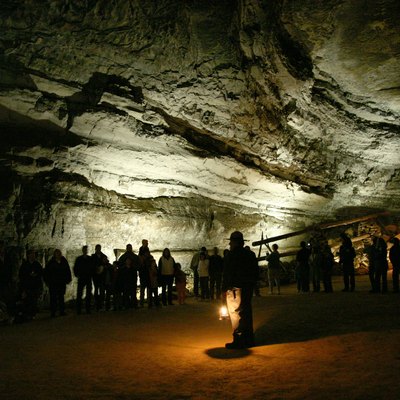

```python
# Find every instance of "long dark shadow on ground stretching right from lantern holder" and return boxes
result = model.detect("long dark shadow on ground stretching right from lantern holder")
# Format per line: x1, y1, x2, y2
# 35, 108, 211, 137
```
254, 292, 400, 347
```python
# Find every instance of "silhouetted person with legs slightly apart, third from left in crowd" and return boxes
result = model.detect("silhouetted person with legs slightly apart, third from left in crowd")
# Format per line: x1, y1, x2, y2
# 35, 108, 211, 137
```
74, 246, 94, 314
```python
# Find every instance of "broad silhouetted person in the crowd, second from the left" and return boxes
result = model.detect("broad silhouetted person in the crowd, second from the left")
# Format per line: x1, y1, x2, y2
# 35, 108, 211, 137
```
43, 249, 72, 318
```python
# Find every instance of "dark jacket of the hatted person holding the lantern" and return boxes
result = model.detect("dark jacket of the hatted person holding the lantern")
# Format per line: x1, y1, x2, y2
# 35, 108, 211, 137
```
222, 247, 258, 291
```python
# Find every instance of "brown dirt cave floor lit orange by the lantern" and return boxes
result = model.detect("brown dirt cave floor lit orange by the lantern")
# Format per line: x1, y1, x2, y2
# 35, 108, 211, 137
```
0, 276, 400, 400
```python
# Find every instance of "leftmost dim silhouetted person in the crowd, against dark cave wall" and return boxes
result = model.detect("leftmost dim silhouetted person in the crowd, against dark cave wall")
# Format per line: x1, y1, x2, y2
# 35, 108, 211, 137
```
19, 249, 43, 319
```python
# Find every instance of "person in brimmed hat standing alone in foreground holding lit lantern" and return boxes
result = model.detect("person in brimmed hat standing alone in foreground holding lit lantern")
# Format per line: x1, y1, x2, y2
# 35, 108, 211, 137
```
222, 231, 258, 349
